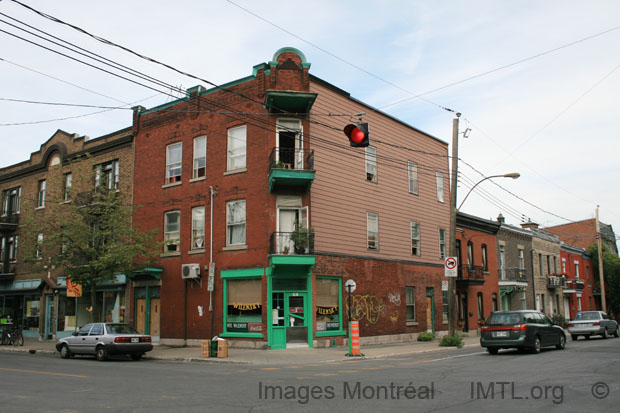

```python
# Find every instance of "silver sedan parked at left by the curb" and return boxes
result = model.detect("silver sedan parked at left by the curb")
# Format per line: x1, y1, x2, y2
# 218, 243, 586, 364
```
56, 323, 153, 361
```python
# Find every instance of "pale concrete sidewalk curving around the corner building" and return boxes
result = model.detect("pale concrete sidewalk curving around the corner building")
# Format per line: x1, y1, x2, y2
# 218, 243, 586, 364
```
0, 336, 480, 365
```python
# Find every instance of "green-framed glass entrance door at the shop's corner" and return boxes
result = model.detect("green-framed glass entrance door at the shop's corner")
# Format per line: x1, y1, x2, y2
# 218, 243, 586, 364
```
271, 292, 309, 349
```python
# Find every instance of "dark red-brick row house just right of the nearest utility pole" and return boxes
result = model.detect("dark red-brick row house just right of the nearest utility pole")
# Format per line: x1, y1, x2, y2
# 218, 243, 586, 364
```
456, 212, 500, 331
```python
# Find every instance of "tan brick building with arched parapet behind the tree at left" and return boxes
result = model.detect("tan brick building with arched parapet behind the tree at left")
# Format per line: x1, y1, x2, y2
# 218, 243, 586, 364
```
0, 129, 133, 338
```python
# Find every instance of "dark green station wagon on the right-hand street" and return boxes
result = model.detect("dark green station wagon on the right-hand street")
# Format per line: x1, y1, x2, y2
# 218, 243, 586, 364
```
480, 310, 566, 354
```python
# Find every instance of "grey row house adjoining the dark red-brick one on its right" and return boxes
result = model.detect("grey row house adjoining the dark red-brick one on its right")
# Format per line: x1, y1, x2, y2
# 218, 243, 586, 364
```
497, 214, 535, 310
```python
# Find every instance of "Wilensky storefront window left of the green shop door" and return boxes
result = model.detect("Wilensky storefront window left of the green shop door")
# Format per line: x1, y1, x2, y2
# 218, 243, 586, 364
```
226, 278, 263, 333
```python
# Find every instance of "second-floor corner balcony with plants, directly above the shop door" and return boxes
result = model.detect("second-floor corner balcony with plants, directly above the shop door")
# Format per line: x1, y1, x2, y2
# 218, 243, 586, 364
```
269, 232, 315, 276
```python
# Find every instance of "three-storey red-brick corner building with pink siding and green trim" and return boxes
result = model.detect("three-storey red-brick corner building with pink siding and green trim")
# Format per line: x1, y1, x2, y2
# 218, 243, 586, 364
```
132, 48, 450, 349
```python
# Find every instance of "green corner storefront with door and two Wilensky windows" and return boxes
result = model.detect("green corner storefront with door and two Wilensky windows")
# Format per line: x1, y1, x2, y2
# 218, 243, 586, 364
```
221, 255, 345, 349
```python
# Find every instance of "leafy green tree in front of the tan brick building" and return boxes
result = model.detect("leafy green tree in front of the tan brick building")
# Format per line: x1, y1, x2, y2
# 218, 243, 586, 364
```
20, 160, 160, 322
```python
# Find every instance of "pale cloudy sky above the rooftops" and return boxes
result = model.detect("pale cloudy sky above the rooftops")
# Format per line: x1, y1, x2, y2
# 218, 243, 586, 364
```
0, 0, 620, 248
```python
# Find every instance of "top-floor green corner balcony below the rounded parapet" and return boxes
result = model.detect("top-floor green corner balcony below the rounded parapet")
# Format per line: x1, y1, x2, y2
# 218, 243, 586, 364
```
269, 148, 315, 193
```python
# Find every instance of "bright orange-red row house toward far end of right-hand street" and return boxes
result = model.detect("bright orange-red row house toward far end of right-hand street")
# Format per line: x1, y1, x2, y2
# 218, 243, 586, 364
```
560, 243, 600, 320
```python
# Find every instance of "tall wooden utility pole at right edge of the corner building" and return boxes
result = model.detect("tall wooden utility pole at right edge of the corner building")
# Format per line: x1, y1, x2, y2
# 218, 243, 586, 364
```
448, 113, 461, 336
